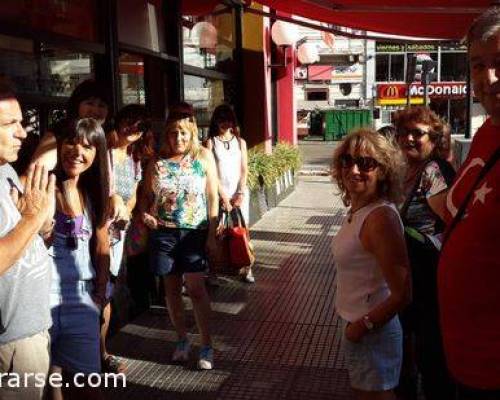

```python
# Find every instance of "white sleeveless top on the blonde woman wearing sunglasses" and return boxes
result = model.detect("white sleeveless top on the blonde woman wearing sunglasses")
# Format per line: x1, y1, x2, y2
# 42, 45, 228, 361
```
332, 200, 403, 322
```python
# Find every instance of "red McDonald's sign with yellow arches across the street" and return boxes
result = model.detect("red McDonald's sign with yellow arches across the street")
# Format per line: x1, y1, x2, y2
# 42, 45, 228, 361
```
377, 82, 467, 100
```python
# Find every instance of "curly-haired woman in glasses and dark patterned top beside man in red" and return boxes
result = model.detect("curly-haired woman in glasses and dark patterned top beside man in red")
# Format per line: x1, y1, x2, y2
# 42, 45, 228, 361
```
393, 107, 455, 400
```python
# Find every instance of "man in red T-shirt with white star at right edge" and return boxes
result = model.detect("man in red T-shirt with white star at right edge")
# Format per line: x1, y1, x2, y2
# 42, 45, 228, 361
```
431, 8, 500, 400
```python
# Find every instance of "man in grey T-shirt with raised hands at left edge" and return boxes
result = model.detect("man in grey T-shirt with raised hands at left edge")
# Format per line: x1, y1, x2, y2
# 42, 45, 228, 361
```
0, 82, 55, 400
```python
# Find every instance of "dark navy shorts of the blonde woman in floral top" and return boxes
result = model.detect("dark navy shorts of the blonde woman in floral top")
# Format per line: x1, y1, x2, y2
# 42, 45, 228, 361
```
149, 228, 208, 276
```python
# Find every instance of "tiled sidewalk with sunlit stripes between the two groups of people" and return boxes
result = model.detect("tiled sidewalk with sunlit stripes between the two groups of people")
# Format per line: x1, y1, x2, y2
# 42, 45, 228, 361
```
106, 176, 352, 400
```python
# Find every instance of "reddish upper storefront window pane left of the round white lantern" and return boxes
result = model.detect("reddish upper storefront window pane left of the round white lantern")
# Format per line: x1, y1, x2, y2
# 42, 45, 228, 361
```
117, 0, 166, 52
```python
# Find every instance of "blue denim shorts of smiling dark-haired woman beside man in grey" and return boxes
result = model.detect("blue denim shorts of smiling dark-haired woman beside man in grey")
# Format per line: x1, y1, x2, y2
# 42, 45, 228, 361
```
49, 281, 101, 374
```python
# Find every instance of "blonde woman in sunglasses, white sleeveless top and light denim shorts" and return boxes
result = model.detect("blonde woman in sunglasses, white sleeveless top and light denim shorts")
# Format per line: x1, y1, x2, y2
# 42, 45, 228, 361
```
332, 129, 409, 399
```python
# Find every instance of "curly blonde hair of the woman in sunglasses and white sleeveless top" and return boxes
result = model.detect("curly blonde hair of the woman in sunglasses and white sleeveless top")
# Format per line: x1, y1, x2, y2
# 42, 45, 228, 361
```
332, 128, 406, 206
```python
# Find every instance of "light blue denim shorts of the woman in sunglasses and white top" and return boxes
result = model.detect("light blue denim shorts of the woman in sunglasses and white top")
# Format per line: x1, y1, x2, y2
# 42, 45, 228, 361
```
341, 316, 403, 391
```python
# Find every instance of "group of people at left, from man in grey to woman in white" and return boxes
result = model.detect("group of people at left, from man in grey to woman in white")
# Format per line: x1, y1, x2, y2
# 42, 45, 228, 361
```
0, 75, 254, 399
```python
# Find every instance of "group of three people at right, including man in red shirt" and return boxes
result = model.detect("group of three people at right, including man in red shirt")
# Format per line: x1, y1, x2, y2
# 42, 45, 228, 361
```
332, 8, 500, 400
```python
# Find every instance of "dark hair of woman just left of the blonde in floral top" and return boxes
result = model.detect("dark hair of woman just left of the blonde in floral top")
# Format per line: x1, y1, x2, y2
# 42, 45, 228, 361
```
110, 104, 155, 162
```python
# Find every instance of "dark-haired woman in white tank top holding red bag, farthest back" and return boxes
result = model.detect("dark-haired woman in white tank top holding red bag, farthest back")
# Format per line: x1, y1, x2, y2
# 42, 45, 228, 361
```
206, 104, 255, 283
